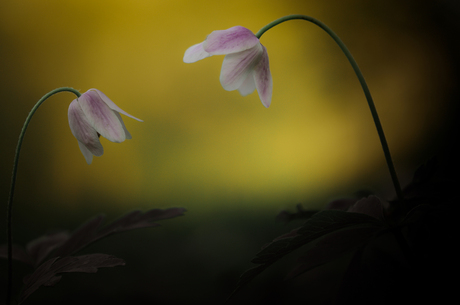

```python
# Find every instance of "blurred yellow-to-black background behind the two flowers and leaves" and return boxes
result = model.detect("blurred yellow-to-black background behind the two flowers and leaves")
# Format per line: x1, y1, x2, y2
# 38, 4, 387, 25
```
0, 0, 459, 304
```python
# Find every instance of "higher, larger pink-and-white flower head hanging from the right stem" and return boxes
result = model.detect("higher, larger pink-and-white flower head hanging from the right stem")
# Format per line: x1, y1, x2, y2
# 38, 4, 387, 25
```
184, 26, 273, 107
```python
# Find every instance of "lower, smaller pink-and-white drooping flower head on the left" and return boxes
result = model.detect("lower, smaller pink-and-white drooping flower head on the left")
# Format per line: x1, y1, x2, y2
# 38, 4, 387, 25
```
68, 89, 142, 164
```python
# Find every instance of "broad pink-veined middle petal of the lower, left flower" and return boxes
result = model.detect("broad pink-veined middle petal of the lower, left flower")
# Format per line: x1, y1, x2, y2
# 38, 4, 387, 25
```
77, 90, 126, 144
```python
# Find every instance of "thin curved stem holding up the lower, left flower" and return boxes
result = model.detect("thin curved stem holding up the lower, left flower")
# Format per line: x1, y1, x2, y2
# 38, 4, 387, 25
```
6, 87, 81, 304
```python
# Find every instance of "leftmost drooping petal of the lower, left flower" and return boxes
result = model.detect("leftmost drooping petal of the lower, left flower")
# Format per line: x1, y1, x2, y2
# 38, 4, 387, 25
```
68, 100, 104, 158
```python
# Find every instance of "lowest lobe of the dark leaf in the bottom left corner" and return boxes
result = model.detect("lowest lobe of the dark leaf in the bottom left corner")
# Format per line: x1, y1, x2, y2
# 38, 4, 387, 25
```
19, 253, 125, 304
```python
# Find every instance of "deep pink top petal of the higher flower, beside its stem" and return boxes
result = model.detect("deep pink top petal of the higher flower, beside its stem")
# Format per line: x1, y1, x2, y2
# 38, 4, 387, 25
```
203, 26, 259, 55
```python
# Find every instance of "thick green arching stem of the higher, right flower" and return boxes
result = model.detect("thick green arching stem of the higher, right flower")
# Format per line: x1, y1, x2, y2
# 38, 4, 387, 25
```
256, 15, 403, 202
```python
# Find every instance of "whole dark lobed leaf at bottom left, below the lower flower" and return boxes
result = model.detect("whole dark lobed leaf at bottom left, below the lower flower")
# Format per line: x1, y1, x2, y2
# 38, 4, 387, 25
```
0, 208, 186, 301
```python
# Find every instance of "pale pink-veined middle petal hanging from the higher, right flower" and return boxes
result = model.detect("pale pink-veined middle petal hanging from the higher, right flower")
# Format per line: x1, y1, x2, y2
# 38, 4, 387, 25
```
220, 44, 262, 91
